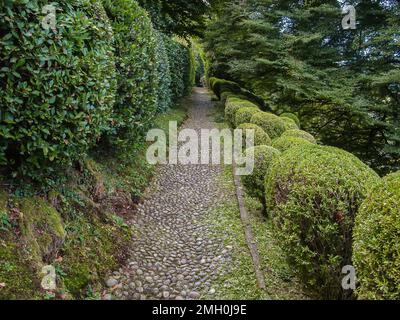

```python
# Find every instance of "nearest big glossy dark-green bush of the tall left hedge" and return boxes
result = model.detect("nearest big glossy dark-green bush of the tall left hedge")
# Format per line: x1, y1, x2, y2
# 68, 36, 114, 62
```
0, 0, 116, 178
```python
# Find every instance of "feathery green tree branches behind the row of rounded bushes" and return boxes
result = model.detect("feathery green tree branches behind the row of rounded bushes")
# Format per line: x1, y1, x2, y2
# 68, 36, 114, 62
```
205, 0, 400, 172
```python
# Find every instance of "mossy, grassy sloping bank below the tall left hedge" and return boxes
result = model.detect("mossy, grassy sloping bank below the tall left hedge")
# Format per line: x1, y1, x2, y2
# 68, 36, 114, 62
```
0, 106, 187, 299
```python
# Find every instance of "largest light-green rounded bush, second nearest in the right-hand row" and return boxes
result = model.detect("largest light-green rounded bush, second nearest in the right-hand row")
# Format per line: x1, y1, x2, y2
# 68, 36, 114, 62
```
265, 144, 379, 299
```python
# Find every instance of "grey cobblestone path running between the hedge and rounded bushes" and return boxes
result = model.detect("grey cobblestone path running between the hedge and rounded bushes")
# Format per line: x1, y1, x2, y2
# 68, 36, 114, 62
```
107, 88, 239, 300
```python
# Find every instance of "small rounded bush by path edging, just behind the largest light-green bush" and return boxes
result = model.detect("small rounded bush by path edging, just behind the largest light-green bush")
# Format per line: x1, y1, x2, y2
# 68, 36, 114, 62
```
242, 145, 281, 203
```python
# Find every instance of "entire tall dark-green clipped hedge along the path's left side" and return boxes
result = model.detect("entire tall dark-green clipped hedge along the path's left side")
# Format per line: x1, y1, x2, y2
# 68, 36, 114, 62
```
0, 0, 196, 179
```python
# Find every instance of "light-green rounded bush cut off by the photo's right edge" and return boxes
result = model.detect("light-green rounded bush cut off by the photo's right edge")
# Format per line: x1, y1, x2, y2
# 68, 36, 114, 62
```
353, 172, 400, 300
